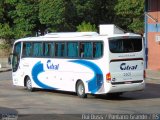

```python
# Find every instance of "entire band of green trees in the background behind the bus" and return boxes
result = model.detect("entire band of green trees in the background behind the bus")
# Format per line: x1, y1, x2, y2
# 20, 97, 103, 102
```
0, 0, 144, 44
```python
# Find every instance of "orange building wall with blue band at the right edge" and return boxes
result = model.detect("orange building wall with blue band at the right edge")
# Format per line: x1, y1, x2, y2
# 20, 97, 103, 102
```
145, 0, 160, 70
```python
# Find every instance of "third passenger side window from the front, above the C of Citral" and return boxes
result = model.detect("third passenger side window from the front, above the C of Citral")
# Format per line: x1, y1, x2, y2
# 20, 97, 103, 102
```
43, 42, 54, 57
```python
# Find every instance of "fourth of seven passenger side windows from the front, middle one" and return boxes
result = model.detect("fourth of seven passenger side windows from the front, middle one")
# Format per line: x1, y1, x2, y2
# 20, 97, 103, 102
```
55, 42, 66, 57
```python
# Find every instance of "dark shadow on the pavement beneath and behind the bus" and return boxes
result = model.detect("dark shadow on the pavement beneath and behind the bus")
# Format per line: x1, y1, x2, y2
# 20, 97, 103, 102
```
21, 83, 160, 101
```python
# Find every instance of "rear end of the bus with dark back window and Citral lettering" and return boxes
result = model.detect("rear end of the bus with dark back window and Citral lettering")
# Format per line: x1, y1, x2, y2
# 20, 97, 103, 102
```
106, 36, 145, 93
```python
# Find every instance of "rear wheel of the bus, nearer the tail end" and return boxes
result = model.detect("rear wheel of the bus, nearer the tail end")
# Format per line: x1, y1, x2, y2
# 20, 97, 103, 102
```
76, 81, 87, 98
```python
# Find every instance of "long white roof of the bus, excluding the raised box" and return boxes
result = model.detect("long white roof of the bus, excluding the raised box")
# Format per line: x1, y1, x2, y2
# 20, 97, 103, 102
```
16, 32, 141, 42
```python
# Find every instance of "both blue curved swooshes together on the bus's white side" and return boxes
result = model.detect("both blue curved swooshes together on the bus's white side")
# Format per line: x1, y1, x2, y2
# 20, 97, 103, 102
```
32, 60, 103, 93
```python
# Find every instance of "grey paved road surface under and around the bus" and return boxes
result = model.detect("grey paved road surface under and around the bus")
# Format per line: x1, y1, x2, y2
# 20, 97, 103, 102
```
0, 72, 160, 119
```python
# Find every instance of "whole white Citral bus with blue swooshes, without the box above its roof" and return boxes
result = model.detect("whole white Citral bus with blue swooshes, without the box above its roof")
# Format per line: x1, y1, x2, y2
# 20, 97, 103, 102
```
12, 24, 145, 98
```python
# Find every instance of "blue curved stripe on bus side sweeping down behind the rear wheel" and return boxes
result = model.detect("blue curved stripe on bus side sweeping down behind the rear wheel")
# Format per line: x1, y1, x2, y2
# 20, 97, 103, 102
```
70, 60, 103, 93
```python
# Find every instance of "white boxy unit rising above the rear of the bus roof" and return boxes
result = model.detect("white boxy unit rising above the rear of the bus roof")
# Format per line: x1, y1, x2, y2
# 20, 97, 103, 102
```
99, 24, 125, 35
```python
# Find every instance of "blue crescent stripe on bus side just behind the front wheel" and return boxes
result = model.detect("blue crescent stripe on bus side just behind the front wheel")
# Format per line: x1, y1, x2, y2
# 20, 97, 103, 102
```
32, 61, 57, 90
